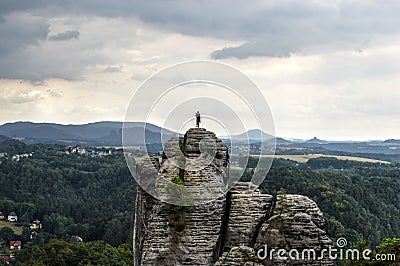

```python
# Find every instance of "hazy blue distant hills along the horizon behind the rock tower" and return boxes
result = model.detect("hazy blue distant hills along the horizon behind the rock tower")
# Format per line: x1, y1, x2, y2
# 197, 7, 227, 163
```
0, 121, 400, 153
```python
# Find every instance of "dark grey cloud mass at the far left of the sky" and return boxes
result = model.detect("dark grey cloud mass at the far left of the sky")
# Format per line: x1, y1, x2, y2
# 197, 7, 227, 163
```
0, 12, 82, 81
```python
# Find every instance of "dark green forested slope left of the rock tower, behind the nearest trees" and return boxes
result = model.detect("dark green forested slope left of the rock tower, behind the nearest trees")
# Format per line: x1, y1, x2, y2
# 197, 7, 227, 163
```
0, 140, 135, 246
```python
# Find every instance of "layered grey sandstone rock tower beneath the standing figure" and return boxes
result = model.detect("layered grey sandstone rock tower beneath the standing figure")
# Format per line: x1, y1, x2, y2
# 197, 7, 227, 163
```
134, 128, 333, 266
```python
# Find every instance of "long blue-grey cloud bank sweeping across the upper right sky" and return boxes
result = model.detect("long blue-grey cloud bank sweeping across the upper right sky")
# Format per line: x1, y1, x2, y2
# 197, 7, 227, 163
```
46, 0, 400, 54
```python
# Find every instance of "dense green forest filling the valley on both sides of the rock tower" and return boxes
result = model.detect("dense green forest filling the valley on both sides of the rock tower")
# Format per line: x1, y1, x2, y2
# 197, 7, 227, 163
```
0, 140, 400, 265
